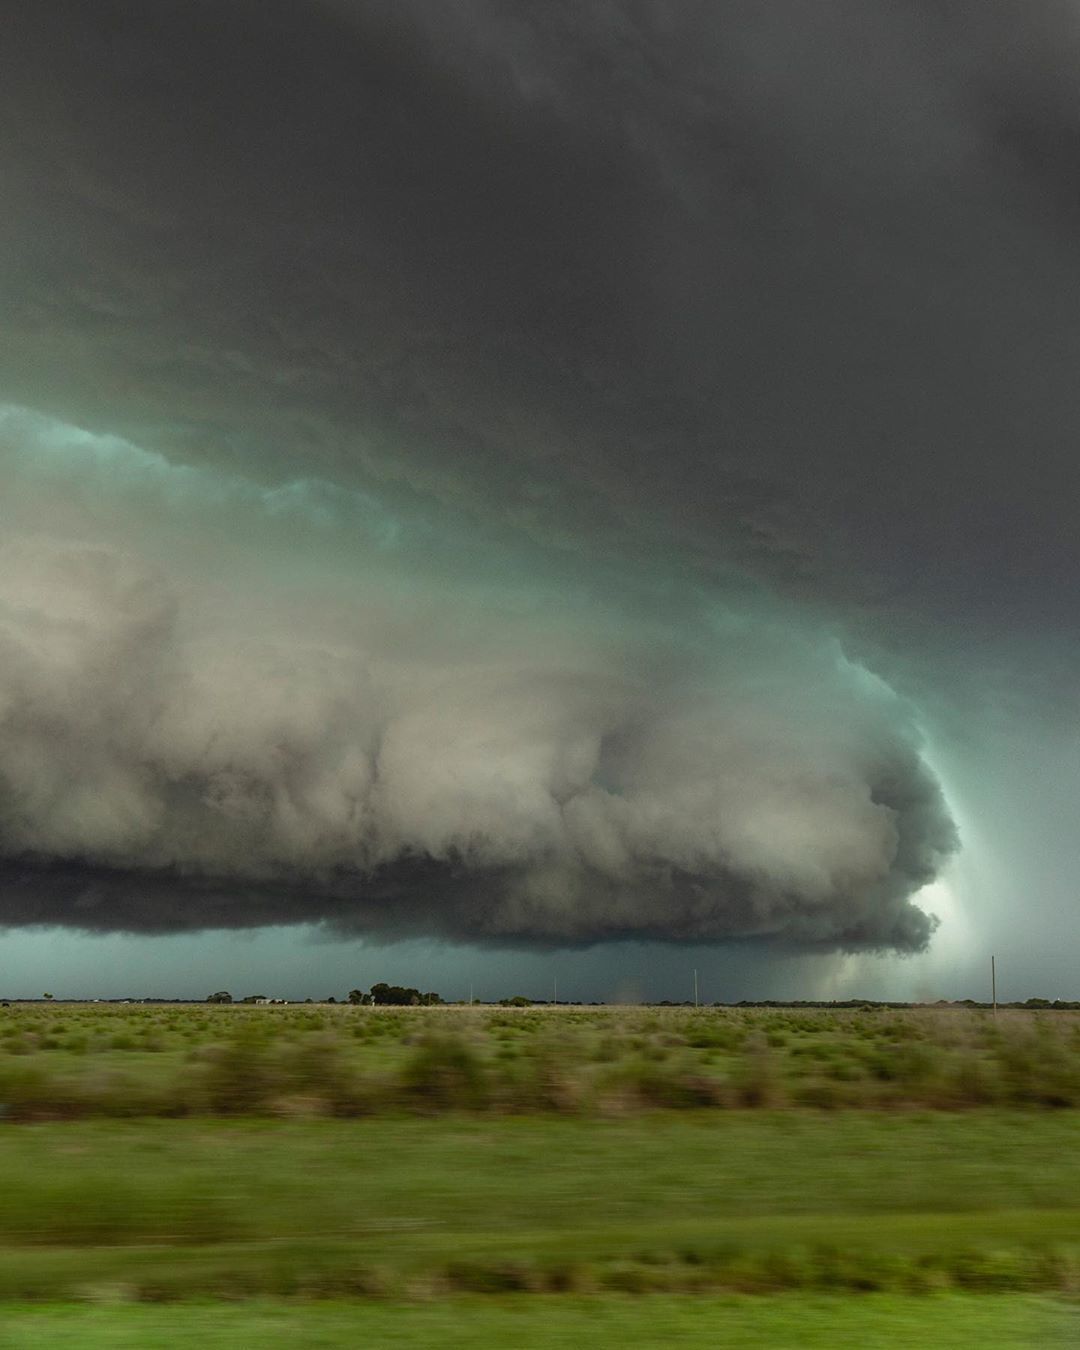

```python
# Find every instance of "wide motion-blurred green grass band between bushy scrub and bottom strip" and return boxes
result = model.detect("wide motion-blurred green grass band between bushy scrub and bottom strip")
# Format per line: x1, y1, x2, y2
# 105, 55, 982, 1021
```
0, 1112, 1080, 1299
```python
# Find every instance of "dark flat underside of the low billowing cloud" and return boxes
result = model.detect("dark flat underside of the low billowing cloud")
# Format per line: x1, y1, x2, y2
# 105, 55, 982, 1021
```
0, 837, 938, 953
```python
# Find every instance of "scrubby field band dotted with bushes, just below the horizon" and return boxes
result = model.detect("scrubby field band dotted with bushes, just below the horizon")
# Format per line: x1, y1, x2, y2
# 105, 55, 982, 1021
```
0, 1004, 1080, 1121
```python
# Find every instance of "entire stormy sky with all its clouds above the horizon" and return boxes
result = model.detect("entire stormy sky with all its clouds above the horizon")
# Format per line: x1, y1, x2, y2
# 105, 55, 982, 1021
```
0, 0, 1080, 996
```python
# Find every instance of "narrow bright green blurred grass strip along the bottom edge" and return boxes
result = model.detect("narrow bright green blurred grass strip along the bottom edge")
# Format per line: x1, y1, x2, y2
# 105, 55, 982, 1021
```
0, 1295, 1080, 1350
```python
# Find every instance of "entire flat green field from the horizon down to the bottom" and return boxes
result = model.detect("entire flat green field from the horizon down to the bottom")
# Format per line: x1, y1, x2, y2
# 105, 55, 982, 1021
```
0, 1004, 1080, 1347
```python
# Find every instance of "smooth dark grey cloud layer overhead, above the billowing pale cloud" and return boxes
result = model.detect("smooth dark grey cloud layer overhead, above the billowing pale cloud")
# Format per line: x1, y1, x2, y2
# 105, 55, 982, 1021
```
3, 0, 1080, 608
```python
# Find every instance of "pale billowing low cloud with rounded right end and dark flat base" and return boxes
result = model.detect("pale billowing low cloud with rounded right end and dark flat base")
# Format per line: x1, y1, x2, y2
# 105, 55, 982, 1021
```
0, 412, 956, 950
